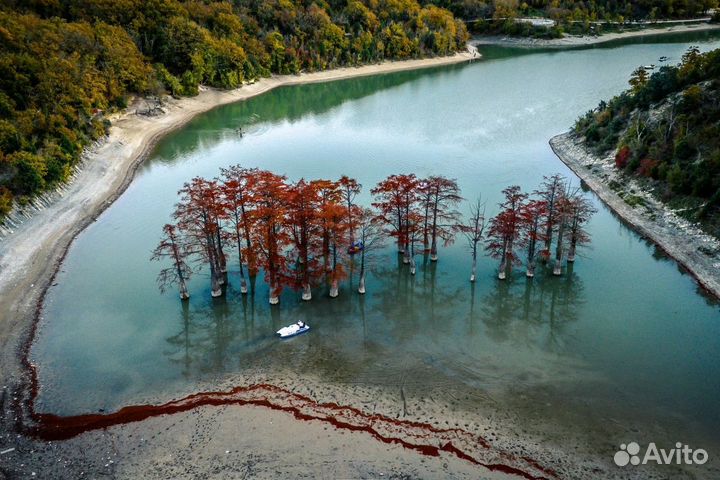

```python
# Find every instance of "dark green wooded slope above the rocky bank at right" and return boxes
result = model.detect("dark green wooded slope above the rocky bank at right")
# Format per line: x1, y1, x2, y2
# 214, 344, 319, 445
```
575, 47, 720, 237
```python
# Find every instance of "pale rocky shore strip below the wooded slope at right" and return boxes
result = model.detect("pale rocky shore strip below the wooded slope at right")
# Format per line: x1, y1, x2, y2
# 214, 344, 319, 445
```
550, 133, 720, 298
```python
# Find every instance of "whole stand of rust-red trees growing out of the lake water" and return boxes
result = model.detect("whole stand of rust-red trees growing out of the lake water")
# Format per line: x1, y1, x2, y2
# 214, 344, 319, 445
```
152, 166, 595, 304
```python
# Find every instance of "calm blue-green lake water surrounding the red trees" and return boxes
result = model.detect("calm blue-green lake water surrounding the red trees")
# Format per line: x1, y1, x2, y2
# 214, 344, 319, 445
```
32, 36, 720, 462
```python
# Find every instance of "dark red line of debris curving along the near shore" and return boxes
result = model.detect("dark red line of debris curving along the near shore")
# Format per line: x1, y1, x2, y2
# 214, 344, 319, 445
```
25, 384, 559, 480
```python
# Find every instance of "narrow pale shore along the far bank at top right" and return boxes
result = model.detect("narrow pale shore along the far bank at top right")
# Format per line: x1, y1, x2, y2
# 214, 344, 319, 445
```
470, 23, 720, 48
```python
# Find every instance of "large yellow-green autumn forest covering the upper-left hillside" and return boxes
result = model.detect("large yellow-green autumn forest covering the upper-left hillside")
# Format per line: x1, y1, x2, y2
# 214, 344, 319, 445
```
0, 0, 468, 221
